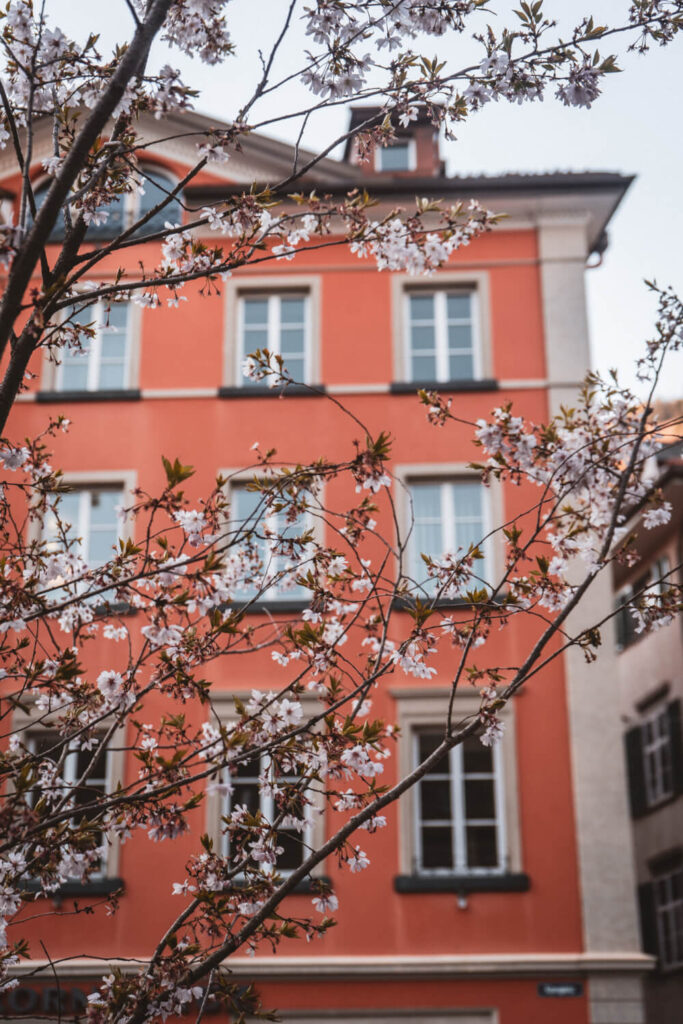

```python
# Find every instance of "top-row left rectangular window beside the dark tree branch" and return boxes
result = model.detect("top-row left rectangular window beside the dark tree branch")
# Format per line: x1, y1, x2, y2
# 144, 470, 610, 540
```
56, 302, 131, 391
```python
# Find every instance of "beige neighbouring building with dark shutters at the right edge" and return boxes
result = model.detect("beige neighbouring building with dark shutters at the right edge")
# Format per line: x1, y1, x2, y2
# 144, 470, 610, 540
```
614, 441, 683, 1024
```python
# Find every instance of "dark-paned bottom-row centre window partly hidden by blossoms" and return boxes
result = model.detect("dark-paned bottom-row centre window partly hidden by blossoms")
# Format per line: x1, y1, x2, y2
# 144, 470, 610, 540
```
222, 755, 312, 874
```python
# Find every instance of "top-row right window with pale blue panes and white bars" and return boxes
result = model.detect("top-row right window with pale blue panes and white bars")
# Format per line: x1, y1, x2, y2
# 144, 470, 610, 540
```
405, 289, 480, 383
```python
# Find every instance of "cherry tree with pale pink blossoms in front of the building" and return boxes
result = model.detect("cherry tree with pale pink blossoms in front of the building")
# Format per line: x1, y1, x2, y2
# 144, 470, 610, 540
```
0, 0, 683, 1024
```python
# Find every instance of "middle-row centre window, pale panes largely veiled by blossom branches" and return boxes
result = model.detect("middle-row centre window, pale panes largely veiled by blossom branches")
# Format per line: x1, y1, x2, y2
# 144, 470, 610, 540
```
232, 486, 310, 601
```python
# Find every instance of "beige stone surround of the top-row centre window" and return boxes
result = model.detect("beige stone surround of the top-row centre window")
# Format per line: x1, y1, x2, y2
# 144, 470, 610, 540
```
223, 273, 322, 393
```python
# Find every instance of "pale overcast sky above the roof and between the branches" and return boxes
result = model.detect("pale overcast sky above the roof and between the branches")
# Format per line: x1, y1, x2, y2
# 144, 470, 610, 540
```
47, 0, 683, 398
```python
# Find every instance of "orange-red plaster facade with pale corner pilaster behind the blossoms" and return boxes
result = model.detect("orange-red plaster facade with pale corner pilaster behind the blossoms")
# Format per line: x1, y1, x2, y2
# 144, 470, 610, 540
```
3, 110, 650, 1024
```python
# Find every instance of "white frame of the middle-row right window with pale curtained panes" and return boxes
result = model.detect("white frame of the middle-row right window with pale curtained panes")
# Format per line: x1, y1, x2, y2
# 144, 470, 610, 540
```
405, 474, 494, 593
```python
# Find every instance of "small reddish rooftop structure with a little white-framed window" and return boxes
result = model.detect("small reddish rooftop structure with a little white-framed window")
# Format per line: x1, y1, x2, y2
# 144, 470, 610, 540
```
344, 106, 443, 178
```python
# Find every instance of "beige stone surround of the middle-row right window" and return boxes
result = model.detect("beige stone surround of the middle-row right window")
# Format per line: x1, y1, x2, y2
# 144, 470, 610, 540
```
394, 462, 505, 585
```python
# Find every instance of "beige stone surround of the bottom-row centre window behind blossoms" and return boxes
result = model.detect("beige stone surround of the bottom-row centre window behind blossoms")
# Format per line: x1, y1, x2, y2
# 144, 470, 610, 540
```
205, 690, 326, 878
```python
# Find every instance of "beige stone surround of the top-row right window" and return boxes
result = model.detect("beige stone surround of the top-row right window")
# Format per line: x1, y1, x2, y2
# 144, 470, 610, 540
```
391, 268, 494, 387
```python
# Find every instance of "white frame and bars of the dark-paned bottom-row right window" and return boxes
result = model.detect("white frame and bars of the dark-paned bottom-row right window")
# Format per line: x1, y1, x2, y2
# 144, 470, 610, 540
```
412, 725, 507, 878
